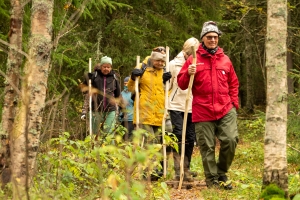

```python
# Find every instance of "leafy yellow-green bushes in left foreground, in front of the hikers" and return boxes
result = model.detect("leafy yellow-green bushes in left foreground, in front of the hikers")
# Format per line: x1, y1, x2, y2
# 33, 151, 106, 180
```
31, 132, 176, 200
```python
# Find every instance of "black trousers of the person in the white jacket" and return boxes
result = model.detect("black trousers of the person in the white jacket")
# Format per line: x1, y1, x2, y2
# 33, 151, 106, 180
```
170, 110, 196, 168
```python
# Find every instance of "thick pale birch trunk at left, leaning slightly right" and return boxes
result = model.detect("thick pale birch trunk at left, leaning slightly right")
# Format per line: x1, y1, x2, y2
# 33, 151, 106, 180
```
10, 0, 54, 199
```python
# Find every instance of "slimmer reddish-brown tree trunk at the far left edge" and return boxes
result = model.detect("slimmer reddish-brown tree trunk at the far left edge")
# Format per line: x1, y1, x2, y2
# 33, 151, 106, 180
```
0, 0, 23, 188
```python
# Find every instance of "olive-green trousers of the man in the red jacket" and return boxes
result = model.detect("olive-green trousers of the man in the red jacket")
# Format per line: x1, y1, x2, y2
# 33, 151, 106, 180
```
195, 108, 238, 185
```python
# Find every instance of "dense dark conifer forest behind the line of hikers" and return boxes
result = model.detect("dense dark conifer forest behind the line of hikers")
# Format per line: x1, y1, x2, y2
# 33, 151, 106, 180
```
0, 0, 300, 135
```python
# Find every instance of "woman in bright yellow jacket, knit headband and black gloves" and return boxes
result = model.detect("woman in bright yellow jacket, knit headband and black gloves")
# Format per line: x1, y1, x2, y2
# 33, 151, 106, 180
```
128, 47, 171, 144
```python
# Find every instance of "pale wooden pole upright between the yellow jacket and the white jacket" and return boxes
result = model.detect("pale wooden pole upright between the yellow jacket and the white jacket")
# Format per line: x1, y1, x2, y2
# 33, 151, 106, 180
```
162, 46, 170, 178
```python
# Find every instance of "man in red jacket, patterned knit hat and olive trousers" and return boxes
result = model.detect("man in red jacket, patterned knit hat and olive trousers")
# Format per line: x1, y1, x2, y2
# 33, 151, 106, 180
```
177, 21, 239, 190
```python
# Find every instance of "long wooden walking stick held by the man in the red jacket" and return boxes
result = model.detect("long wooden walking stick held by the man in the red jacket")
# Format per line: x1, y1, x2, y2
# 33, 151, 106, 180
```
178, 46, 197, 190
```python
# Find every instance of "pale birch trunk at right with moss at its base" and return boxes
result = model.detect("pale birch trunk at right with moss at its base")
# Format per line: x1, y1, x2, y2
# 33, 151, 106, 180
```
263, 0, 288, 197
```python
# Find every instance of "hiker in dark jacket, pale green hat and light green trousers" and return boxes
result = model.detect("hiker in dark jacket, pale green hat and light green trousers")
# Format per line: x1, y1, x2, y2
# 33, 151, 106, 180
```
81, 56, 121, 134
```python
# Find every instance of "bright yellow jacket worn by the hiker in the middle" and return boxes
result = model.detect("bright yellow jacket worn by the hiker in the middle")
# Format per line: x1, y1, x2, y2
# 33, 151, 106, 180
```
127, 56, 165, 126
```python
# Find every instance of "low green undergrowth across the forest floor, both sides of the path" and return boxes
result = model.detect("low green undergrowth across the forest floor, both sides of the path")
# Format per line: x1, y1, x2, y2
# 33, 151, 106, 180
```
0, 109, 300, 200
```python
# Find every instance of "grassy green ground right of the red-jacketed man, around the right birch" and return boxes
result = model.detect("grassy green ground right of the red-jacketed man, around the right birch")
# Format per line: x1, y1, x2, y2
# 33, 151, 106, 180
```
192, 112, 300, 200
